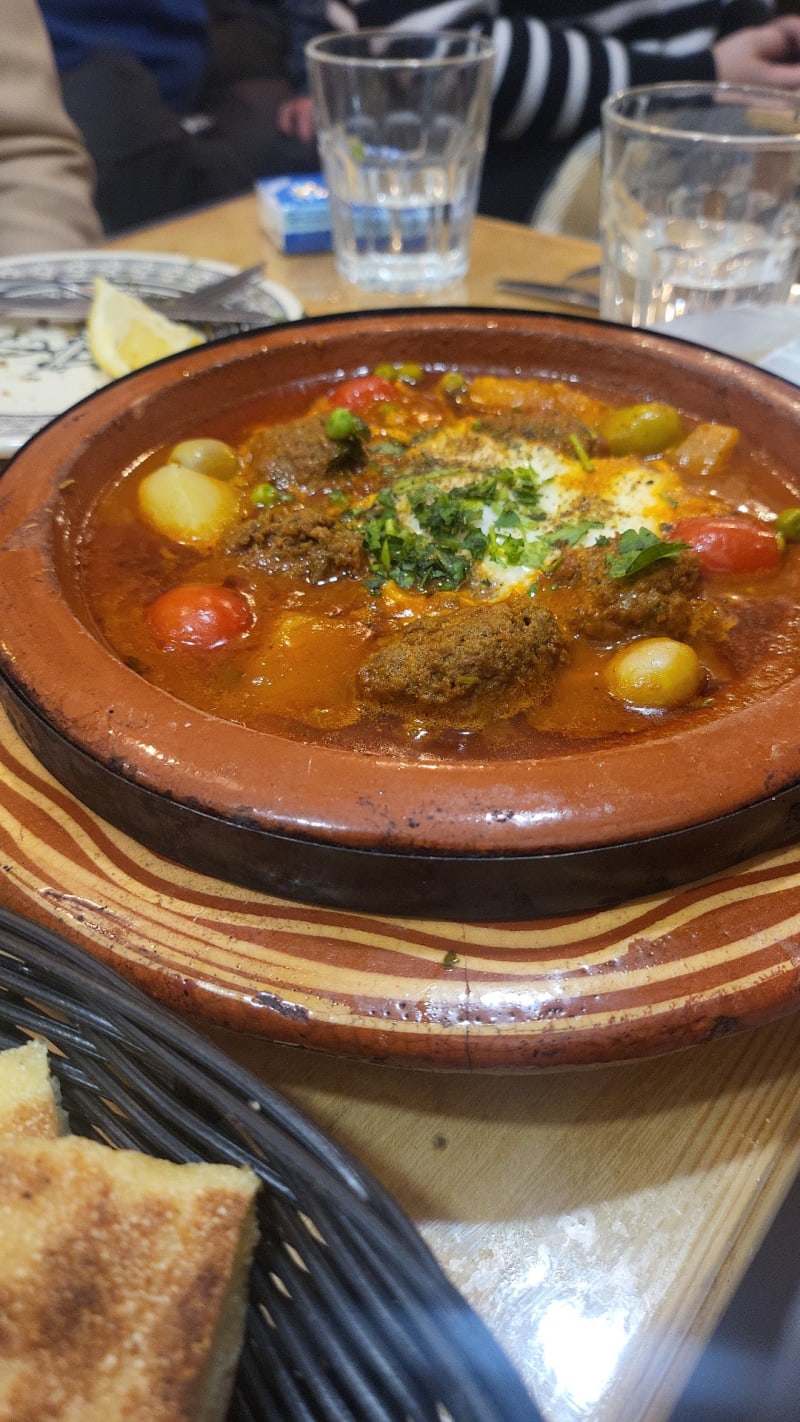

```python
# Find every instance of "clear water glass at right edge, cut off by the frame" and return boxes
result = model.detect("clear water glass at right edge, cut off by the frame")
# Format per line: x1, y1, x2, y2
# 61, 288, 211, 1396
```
600, 84, 800, 326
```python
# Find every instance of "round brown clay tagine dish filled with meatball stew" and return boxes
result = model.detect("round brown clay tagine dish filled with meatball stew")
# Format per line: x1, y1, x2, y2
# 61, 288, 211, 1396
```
0, 309, 800, 920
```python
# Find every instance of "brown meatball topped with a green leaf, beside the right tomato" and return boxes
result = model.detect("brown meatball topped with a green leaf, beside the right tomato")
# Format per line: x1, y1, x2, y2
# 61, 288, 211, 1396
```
550, 546, 712, 641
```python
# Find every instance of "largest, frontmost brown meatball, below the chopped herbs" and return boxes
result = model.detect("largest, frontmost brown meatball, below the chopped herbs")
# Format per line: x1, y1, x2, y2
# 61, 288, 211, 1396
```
358, 597, 566, 728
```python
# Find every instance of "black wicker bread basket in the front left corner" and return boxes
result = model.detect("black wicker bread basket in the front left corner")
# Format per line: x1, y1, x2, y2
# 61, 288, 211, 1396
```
0, 909, 541, 1422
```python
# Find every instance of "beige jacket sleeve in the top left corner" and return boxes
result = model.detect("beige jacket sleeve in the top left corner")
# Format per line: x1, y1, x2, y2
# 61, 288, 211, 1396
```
0, 0, 102, 256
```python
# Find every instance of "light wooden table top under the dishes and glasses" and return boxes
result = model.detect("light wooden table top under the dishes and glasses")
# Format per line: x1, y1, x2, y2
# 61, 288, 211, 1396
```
12, 198, 800, 1422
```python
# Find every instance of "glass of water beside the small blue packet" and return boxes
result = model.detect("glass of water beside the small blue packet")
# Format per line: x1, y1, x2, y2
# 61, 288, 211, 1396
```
306, 30, 493, 293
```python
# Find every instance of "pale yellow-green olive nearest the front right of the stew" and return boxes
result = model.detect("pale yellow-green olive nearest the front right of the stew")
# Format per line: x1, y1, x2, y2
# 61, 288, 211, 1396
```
605, 637, 703, 711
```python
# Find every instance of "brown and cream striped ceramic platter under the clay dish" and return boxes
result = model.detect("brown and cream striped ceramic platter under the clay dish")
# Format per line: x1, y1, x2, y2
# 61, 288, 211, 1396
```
0, 715, 800, 1071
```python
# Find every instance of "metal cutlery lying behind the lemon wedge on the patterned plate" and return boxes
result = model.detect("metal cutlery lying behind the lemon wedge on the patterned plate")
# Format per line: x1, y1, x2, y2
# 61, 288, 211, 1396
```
0, 262, 267, 326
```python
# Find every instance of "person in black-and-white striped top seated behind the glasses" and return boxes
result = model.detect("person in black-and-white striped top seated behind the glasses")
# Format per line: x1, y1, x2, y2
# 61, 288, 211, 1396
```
279, 0, 800, 220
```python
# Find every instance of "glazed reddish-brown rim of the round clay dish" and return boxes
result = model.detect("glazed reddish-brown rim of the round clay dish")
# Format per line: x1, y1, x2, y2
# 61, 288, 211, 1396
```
0, 307, 800, 857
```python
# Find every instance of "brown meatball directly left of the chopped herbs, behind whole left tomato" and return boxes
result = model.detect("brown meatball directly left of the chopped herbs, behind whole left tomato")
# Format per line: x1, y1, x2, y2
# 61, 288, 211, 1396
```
226, 503, 367, 583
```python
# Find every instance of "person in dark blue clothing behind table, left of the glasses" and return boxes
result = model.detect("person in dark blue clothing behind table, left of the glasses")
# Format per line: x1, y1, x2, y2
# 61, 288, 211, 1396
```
34, 0, 317, 235
